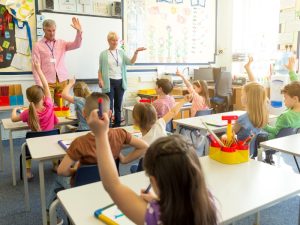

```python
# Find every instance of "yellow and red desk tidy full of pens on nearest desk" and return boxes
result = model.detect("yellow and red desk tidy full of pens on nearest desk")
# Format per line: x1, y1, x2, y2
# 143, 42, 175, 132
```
202, 116, 251, 164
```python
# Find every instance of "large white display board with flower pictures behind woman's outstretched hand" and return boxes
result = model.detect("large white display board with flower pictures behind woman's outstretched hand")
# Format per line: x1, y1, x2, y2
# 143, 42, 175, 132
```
124, 0, 217, 64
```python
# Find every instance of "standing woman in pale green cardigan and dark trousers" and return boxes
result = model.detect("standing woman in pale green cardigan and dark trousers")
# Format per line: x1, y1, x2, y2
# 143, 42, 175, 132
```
98, 32, 146, 127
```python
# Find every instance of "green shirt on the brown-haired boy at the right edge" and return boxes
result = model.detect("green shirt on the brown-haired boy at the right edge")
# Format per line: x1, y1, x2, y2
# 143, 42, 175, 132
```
264, 109, 300, 139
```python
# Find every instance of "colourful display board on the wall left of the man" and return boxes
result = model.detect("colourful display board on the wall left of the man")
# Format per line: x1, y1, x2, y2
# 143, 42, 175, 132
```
0, 0, 36, 75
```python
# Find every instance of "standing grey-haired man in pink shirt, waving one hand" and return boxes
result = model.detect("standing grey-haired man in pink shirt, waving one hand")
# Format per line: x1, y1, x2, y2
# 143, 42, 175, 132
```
32, 17, 82, 105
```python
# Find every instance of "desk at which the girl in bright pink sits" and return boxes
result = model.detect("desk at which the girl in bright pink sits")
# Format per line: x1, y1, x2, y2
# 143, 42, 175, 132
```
0, 117, 77, 186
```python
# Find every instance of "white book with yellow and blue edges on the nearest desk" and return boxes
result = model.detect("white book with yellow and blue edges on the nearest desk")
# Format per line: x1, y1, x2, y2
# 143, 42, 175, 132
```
94, 204, 134, 225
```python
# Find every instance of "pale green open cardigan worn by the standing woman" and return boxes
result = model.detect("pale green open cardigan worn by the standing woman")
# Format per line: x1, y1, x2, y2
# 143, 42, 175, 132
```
99, 49, 132, 93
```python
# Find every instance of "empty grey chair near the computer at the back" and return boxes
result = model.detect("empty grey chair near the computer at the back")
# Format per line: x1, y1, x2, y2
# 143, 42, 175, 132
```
210, 68, 232, 113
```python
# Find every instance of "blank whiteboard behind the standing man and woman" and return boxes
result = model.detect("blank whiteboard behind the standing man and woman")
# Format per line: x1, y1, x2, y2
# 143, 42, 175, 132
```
42, 12, 122, 79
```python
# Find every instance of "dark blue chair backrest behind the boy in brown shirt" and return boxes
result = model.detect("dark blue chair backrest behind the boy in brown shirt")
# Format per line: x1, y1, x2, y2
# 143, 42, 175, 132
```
74, 165, 100, 187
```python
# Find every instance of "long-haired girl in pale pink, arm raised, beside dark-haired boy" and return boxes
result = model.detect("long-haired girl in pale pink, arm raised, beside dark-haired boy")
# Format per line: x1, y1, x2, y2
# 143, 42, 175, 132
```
176, 70, 210, 117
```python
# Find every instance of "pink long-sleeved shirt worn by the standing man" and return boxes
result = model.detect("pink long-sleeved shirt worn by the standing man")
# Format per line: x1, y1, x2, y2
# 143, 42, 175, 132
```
32, 32, 82, 86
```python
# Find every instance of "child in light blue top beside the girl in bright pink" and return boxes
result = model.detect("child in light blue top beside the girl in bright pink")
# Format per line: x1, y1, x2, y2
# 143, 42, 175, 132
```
61, 79, 91, 130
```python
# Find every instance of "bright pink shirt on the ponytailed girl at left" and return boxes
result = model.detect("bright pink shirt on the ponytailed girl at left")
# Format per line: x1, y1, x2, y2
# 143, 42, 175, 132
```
20, 97, 58, 131
